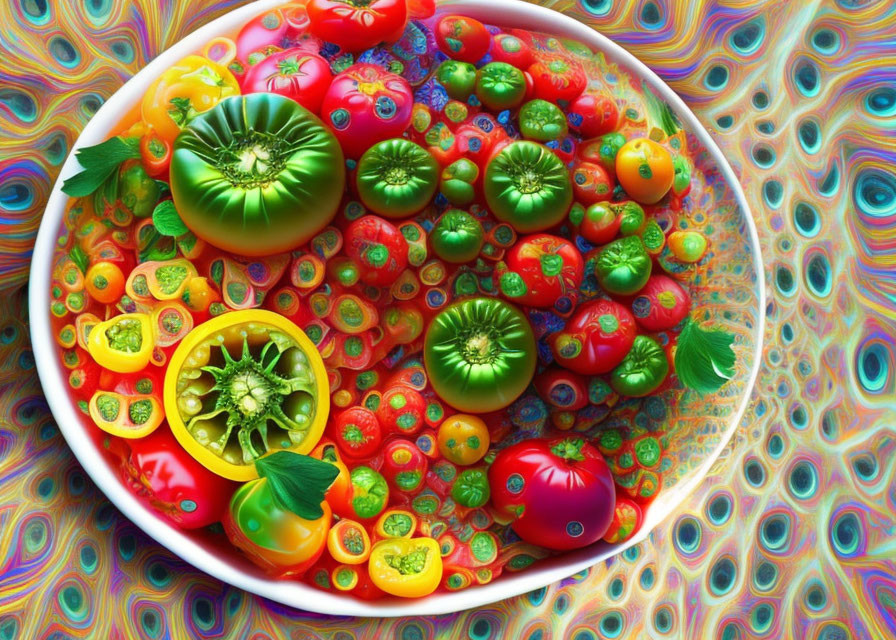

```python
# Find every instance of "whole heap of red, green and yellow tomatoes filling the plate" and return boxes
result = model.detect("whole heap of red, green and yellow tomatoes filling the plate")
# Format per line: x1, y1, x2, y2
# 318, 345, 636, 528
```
51, 0, 707, 598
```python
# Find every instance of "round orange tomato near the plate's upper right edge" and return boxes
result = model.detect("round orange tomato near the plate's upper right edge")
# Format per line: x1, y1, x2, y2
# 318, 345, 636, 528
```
616, 138, 675, 204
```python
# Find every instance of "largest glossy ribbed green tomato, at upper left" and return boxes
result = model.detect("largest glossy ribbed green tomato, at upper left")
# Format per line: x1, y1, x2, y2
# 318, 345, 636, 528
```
171, 93, 345, 256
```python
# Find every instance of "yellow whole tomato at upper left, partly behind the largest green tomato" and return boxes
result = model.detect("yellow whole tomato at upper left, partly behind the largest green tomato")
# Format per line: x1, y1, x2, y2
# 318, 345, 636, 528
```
141, 55, 240, 144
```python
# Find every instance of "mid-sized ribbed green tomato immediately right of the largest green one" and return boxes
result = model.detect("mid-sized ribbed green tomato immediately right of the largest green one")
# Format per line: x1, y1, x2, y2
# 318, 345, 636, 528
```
357, 138, 439, 218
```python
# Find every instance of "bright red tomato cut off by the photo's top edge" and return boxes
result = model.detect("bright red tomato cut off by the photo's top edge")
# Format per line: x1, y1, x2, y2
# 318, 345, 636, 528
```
306, 0, 408, 53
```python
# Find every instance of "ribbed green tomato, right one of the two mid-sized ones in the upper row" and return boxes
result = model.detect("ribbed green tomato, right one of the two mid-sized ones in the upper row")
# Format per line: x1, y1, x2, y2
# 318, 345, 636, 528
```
483, 140, 572, 233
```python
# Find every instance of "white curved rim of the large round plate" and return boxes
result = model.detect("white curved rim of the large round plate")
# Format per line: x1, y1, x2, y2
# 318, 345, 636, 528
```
29, 0, 765, 617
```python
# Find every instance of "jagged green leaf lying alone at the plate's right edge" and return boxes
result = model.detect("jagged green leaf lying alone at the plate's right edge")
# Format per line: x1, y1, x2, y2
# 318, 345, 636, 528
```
675, 320, 736, 393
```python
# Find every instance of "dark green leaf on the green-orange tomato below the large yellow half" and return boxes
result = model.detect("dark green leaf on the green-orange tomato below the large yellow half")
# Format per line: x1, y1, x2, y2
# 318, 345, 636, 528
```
255, 451, 339, 520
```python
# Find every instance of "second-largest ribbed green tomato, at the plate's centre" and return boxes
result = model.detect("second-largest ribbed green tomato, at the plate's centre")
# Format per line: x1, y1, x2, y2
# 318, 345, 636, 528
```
423, 298, 536, 413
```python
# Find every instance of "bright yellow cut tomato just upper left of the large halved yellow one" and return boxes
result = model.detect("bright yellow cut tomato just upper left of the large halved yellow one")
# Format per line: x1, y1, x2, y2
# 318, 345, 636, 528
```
87, 313, 154, 373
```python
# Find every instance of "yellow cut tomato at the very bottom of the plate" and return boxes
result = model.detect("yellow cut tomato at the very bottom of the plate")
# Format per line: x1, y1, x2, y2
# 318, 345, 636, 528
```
368, 538, 442, 598
